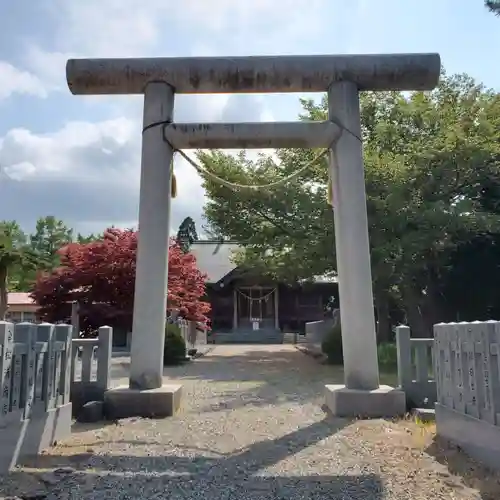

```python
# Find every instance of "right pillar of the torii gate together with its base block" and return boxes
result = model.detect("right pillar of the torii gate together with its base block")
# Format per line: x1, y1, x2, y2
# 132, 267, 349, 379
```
325, 81, 406, 417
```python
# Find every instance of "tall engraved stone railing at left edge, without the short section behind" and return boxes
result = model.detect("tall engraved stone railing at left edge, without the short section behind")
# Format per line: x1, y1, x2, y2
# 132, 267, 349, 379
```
0, 321, 72, 473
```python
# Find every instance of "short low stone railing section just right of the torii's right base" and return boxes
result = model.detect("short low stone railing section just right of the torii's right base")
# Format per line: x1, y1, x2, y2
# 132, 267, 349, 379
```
396, 326, 436, 408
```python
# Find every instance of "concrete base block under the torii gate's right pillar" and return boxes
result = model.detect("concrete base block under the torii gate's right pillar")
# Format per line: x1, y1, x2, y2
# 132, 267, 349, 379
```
325, 385, 406, 418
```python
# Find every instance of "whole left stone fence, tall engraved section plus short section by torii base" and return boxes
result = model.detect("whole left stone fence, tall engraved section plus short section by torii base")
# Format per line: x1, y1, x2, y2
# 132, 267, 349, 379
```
0, 321, 113, 474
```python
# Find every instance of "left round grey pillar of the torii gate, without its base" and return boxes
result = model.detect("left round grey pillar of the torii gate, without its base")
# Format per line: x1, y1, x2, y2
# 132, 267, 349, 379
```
130, 82, 174, 390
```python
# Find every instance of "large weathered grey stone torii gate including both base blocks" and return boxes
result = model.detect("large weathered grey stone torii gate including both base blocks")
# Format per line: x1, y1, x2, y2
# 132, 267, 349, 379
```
66, 54, 440, 417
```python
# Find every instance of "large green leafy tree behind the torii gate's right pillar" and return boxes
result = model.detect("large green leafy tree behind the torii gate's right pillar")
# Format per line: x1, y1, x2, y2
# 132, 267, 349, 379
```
198, 75, 500, 340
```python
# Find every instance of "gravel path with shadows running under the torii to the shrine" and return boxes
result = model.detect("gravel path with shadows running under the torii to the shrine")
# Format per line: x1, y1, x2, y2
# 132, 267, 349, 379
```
0, 345, 500, 500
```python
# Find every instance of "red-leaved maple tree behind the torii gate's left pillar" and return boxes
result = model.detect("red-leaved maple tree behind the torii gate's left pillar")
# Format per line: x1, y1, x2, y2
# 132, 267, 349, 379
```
31, 228, 210, 330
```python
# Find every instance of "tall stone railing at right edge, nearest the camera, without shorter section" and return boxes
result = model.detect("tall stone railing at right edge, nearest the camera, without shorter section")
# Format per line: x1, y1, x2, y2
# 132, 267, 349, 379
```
434, 321, 500, 469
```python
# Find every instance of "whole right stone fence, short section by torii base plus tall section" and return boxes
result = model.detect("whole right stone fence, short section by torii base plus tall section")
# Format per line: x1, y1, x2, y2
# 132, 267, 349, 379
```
396, 321, 500, 469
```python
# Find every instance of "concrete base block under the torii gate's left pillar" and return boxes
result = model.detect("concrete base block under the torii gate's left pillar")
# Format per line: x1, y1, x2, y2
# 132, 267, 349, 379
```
104, 384, 182, 419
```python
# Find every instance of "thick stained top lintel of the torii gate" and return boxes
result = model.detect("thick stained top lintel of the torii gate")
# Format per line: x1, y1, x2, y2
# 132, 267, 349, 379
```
66, 54, 441, 94
